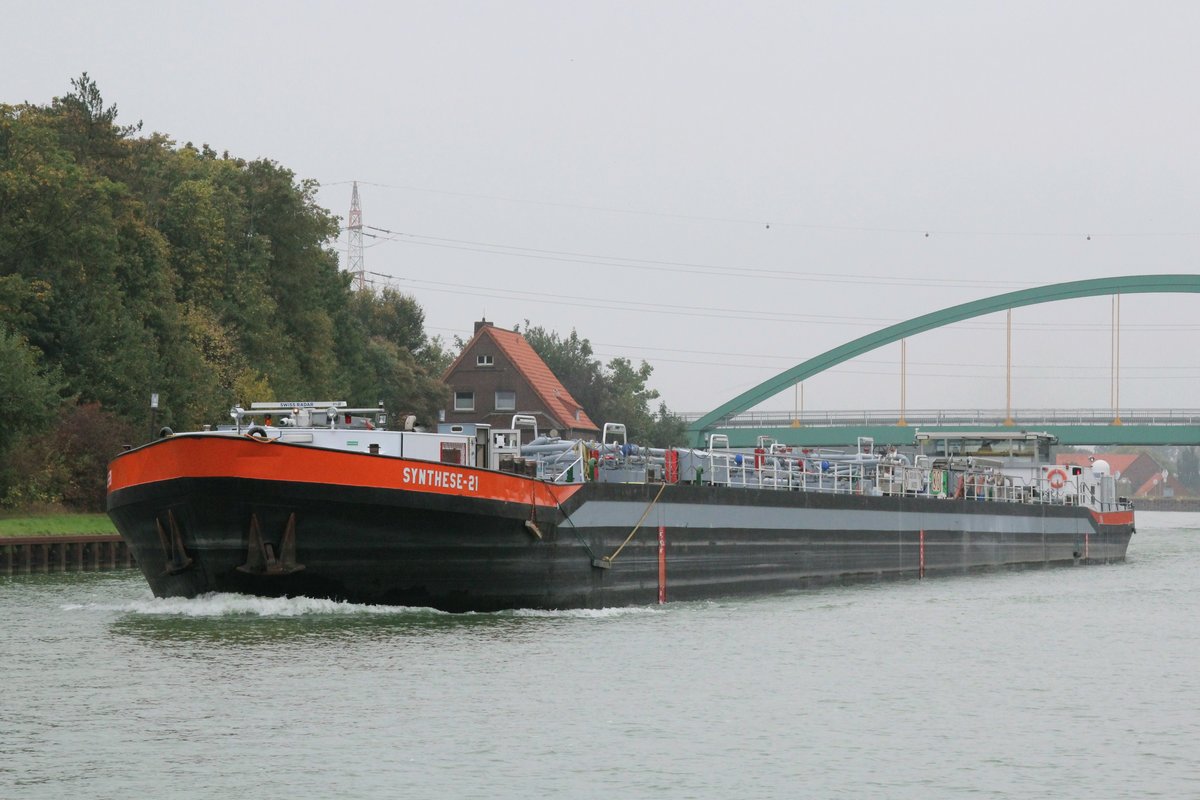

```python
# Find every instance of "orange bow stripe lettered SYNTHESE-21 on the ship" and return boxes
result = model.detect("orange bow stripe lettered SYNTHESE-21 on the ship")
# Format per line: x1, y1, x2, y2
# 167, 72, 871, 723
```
108, 437, 580, 507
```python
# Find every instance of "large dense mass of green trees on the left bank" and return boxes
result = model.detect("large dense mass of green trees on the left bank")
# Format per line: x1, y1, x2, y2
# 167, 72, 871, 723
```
0, 73, 451, 505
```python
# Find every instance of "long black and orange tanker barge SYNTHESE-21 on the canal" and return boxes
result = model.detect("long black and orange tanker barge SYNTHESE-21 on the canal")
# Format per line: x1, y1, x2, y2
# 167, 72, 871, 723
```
108, 402, 1134, 612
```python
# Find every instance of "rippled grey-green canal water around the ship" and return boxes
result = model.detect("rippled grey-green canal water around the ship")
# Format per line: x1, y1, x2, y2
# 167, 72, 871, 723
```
0, 512, 1200, 800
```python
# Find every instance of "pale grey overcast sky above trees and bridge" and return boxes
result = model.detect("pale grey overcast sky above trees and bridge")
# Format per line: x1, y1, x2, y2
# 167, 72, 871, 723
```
0, 0, 1200, 419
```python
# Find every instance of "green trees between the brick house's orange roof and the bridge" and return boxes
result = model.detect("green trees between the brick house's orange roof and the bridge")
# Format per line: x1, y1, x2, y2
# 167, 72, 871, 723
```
516, 319, 688, 447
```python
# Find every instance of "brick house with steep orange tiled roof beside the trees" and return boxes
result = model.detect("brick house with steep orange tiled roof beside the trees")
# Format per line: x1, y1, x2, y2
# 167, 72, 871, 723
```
442, 319, 600, 440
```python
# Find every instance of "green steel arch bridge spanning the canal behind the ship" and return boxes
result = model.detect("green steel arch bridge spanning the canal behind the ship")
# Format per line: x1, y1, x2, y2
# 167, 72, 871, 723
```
688, 275, 1200, 447
